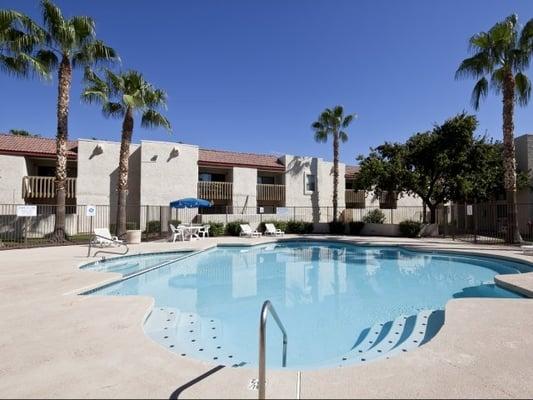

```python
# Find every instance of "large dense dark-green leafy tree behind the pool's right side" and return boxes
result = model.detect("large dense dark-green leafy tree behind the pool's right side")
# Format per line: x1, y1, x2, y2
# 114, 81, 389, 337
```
355, 114, 477, 223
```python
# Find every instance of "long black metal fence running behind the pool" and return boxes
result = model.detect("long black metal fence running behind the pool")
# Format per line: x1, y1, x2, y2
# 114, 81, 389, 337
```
0, 203, 533, 249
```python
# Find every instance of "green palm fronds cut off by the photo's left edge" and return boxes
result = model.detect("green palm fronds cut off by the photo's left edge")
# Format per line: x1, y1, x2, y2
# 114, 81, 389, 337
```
0, 10, 50, 79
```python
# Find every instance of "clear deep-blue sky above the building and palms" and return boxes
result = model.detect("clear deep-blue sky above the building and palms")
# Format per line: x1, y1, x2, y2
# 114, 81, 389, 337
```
0, 0, 533, 163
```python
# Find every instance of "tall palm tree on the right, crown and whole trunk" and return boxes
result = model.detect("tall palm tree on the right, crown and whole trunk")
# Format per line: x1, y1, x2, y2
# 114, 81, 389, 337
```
455, 15, 533, 243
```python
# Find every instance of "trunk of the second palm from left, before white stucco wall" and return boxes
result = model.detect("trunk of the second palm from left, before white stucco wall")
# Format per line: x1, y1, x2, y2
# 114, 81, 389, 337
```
115, 107, 133, 238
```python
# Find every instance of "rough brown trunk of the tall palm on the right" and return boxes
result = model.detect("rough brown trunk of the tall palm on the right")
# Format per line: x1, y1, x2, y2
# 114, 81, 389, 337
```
503, 71, 522, 243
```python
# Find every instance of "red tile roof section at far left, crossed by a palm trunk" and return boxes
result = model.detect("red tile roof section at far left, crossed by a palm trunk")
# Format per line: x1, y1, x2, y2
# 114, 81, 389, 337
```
0, 134, 78, 158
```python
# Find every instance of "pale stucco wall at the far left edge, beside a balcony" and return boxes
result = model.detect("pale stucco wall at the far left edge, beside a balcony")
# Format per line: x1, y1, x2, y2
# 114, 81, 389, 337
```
0, 154, 28, 204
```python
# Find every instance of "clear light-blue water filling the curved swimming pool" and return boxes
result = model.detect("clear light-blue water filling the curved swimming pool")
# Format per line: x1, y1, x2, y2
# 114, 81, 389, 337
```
87, 242, 528, 369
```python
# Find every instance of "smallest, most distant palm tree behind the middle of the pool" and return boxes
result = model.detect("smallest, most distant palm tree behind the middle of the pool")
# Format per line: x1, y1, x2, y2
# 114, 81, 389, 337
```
311, 106, 355, 222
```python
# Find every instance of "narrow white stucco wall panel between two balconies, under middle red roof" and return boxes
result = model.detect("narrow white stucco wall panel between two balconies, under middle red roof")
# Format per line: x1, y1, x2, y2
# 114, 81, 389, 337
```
232, 167, 257, 214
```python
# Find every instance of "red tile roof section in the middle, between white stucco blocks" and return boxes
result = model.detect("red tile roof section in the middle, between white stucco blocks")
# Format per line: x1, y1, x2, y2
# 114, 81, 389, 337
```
198, 149, 285, 171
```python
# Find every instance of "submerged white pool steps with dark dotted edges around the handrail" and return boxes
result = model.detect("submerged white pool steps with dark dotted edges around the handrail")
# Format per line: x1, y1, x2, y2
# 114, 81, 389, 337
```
140, 307, 444, 368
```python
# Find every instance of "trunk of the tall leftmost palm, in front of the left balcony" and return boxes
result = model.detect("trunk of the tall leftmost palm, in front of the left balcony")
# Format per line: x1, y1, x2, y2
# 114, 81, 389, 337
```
53, 56, 72, 242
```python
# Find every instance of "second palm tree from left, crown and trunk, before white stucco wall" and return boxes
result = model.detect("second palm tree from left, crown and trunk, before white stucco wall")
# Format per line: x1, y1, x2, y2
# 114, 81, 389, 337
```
81, 69, 171, 237
